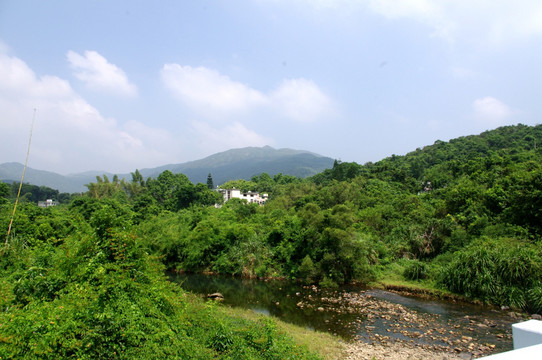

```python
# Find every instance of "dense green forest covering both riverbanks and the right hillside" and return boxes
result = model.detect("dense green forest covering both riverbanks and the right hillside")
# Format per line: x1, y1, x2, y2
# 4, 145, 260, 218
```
0, 125, 542, 359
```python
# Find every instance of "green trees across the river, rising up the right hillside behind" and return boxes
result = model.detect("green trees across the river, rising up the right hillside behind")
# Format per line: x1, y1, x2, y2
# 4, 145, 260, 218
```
116, 125, 542, 310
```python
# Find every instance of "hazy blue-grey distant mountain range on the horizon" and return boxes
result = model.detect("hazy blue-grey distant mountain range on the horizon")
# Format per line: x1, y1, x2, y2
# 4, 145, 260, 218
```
0, 146, 334, 193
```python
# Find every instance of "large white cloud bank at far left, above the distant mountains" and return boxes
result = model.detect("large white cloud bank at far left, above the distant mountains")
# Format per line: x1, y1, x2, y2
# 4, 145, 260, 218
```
0, 53, 176, 173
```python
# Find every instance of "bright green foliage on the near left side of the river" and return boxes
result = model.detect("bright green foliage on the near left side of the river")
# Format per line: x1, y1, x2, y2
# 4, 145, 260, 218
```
0, 200, 324, 359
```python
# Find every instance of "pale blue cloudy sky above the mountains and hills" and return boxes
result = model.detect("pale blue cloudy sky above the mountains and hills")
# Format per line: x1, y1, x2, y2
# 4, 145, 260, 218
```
0, 0, 542, 174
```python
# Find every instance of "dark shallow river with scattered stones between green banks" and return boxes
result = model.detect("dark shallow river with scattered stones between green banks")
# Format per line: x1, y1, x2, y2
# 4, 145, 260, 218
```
171, 274, 523, 355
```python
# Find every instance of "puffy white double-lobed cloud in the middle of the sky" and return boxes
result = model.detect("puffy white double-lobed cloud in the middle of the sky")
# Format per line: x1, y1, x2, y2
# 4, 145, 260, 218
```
161, 64, 334, 122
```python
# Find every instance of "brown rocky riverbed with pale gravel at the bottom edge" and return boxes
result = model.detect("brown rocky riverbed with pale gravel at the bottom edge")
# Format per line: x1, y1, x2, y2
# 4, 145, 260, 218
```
297, 287, 522, 359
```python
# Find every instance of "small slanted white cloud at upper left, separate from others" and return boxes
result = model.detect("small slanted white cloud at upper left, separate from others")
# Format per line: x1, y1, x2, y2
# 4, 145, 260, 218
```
66, 50, 137, 96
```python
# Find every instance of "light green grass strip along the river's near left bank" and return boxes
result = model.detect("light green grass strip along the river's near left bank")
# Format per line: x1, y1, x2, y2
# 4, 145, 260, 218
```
222, 306, 346, 360
